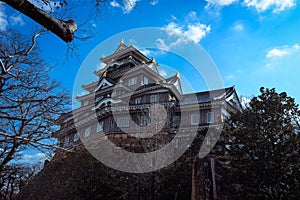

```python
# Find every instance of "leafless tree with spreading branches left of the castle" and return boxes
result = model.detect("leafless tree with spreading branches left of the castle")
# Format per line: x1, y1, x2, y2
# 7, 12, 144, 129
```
0, 31, 70, 180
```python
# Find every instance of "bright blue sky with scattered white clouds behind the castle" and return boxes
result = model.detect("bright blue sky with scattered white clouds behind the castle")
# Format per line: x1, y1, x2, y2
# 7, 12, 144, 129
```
0, 0, 300, 161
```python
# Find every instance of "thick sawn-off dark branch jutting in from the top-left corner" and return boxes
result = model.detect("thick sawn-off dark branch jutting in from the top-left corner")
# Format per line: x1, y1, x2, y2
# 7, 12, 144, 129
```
0, 0, 77, 43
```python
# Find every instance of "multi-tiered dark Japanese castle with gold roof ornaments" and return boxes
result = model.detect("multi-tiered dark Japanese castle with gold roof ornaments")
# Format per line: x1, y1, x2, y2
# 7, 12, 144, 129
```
53, 40, 241, 148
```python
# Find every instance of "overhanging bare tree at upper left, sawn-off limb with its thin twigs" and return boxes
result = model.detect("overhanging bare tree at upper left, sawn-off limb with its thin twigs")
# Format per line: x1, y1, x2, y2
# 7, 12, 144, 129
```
0, 0, 148, 43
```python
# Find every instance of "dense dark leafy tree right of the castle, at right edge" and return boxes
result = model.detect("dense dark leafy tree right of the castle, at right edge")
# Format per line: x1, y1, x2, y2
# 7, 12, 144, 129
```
225, 87, 300, 199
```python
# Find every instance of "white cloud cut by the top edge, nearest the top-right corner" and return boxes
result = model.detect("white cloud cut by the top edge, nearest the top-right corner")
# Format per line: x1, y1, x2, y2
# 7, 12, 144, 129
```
244, 0, 296, 13
